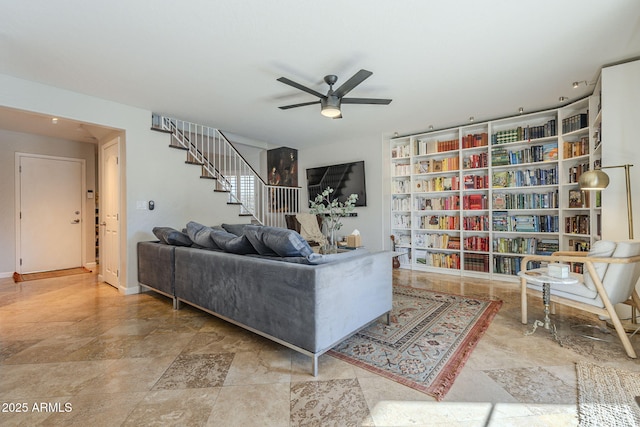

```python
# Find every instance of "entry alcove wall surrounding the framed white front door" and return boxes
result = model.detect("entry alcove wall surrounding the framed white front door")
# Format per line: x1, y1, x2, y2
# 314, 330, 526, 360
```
0, 129, 97, 277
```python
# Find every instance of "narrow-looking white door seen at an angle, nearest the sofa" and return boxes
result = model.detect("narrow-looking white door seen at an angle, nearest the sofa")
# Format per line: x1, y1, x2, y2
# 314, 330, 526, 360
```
100, 138, 120, 287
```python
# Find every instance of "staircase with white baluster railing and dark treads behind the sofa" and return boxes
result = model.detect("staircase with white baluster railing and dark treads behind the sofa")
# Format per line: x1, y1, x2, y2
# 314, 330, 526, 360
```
151, 114, 300, 228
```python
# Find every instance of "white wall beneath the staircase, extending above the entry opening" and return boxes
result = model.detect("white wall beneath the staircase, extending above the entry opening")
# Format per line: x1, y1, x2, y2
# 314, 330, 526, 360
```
0, 75, 255, 293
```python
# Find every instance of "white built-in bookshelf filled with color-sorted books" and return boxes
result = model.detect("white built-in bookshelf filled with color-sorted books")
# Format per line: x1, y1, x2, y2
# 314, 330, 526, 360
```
389, 95, 601, 278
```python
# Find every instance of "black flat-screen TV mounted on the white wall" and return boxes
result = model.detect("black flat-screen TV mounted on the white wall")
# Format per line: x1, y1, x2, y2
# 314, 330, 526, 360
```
307, 160, 367, 206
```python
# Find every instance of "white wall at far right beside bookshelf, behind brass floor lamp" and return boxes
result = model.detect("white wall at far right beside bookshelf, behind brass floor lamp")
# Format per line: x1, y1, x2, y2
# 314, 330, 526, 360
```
602, 60, 640, 240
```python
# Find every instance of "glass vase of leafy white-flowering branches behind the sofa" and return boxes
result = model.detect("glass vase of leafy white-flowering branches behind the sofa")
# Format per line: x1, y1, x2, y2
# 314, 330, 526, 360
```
309, 187, 358, 253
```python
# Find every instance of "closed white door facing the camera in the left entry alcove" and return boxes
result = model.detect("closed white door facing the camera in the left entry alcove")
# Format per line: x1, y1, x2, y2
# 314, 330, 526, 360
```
18, 155, 84, 273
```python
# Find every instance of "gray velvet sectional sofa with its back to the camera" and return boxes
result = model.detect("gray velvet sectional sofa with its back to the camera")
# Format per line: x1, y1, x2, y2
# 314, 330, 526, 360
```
138, 223, 392, 375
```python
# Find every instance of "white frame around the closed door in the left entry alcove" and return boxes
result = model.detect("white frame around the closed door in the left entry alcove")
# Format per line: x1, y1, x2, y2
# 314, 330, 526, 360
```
14, 152, 87, 273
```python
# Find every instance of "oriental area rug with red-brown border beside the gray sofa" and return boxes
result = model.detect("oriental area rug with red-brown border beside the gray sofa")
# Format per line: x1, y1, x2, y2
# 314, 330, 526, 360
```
329, 286, 502, 400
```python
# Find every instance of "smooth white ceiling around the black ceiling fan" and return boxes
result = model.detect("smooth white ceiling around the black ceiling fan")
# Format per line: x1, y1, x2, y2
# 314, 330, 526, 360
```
0, 0, 640, 148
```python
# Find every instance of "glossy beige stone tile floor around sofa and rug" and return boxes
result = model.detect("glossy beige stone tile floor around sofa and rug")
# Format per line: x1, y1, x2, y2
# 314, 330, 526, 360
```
0, 270, 640, 426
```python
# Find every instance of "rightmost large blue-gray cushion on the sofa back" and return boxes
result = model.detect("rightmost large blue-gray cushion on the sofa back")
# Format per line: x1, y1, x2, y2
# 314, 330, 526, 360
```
244, 225, 313, 257
